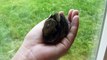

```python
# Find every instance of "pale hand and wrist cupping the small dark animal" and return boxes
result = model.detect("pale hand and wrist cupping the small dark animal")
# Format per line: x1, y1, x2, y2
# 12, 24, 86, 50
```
12, 10, 79, 60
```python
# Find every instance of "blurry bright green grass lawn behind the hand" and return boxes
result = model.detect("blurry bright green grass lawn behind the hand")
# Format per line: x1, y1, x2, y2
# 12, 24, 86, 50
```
0, 0, 104, 60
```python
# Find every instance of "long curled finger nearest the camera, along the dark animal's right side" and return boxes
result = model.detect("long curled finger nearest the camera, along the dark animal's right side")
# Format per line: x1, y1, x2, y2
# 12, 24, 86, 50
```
57, 15, 79, 52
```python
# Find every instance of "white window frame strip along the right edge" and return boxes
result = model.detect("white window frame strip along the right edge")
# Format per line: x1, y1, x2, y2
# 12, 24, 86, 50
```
96, 1, 107, 60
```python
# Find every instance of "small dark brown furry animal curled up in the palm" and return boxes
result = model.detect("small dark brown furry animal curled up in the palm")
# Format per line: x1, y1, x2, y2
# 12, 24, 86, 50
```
42, 13, 69, 44
